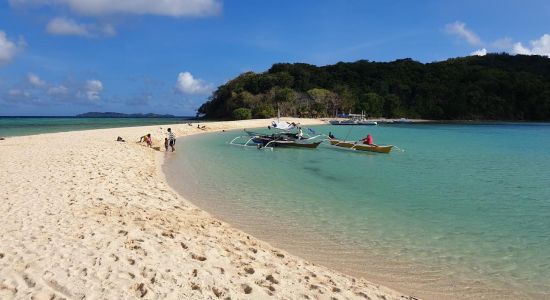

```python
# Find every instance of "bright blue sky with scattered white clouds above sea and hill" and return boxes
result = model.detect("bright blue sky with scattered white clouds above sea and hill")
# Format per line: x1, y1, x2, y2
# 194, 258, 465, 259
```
0, 0, 550, 115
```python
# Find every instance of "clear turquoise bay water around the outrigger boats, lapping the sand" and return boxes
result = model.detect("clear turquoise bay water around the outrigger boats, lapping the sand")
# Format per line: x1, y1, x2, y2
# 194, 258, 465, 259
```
164, 124, 550, 299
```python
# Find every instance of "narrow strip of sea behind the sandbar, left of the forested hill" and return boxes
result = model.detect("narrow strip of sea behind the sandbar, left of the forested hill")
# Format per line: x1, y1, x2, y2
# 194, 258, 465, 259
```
0, 117, 194, 137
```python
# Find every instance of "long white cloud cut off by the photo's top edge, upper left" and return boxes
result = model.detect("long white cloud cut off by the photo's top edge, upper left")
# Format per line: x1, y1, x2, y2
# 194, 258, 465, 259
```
10, 0, 222, 17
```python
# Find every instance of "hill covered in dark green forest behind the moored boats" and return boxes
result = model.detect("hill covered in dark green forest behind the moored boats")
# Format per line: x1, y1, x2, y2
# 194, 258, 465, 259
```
199, 54, 550, 121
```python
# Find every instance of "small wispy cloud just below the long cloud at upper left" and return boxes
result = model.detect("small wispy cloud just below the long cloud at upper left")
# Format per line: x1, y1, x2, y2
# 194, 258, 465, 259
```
46, 17, 116, 37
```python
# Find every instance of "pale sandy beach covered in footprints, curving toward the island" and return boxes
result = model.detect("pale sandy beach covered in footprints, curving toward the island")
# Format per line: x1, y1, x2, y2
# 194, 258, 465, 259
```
0, 119, 412, 299
